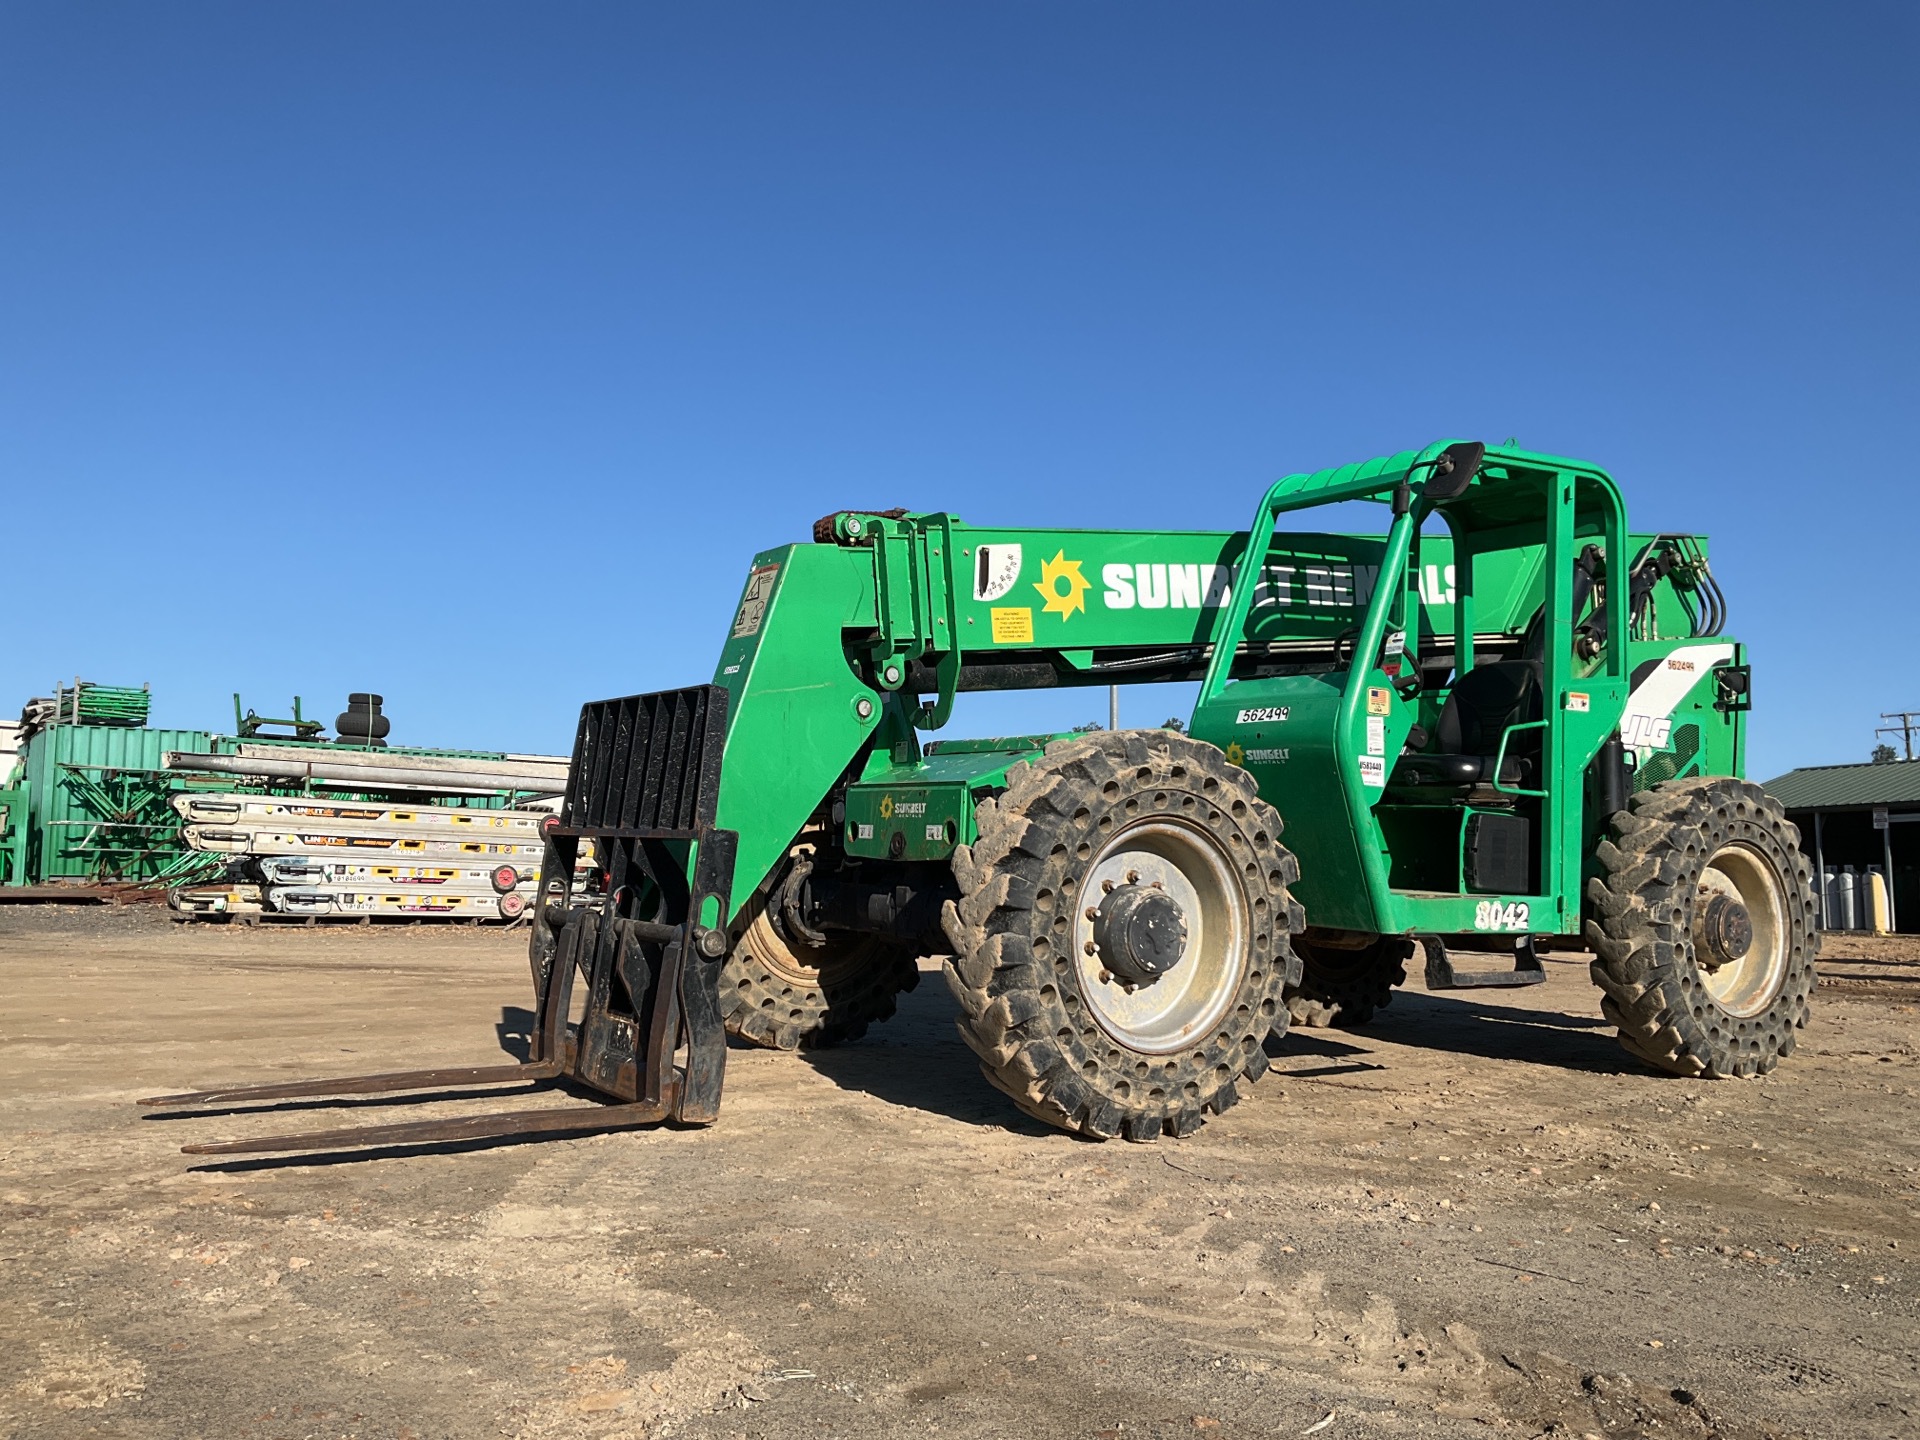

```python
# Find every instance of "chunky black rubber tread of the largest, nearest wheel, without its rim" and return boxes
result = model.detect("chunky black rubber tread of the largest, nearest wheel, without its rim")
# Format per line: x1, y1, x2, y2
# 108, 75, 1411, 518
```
943, 730, 1304, 1140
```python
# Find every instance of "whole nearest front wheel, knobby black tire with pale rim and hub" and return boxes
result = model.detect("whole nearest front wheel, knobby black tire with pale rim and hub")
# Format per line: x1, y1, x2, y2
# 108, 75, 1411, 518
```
943, 730, 1302, 1140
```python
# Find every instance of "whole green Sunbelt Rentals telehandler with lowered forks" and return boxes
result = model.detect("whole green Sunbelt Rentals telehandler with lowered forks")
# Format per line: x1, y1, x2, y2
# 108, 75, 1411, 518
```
154, 442, 1818, 1154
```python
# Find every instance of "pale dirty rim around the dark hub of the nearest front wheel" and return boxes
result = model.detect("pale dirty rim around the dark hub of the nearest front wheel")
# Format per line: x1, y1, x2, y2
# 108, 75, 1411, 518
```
1073, 820, 1246, 1054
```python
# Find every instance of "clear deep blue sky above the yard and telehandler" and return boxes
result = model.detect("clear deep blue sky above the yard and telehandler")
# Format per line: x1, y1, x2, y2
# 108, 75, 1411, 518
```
0, 0, 1920, 778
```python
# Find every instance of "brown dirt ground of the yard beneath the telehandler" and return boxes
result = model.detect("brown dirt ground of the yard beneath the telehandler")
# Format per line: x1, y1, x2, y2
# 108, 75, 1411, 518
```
0, 908, 1920, 1440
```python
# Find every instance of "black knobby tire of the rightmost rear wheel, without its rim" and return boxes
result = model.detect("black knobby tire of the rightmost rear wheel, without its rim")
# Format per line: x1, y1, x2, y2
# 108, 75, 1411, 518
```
1586, 778, 1820, 1079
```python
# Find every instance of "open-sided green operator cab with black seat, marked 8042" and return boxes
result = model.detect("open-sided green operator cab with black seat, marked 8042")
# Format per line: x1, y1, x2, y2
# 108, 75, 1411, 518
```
1194, 442, 1626, 937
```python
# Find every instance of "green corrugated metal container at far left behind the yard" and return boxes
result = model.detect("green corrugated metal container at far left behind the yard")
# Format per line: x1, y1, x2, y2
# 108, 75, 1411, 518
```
15, 726, 213, 883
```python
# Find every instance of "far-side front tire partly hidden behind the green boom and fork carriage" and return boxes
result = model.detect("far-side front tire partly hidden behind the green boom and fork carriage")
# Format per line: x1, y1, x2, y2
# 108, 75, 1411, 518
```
720, 864, 920, 1050
